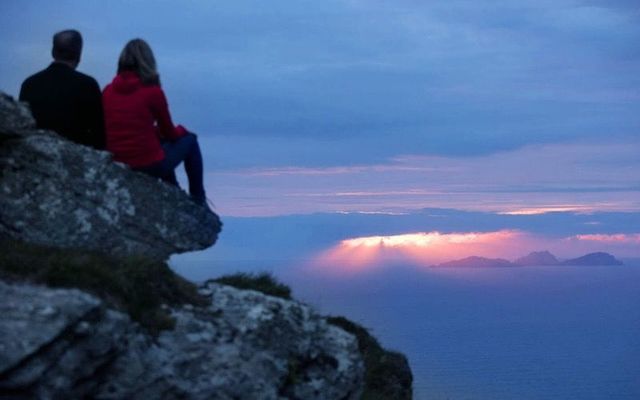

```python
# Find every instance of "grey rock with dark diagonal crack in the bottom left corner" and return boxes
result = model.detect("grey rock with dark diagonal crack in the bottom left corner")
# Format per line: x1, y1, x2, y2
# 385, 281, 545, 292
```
0, 281, 136, 399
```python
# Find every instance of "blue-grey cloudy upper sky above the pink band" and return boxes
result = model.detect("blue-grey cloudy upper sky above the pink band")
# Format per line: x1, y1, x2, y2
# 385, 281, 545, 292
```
0, 1, 640, 162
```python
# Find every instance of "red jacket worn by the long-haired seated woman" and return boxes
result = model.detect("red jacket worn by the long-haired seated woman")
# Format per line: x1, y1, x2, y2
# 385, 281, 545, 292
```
102, 72, 187, 167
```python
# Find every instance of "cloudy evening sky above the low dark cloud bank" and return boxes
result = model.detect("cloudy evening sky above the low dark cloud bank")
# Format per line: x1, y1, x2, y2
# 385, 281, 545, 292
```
0, 0, 640, 262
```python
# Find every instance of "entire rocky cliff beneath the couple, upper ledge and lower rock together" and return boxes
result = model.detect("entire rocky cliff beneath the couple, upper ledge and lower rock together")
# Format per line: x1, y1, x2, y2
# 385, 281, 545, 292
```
0, 94, 411, 400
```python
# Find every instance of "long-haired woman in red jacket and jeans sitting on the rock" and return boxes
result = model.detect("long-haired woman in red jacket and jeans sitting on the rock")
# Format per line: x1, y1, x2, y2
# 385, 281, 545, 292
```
102, 39, 206, 205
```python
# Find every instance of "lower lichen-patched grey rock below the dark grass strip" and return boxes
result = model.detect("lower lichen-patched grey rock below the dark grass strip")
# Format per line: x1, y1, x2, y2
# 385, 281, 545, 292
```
0, 282, 364, 400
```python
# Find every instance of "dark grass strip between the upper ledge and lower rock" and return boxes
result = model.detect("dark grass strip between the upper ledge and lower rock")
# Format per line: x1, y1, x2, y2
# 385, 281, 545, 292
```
0, 239, 208, 334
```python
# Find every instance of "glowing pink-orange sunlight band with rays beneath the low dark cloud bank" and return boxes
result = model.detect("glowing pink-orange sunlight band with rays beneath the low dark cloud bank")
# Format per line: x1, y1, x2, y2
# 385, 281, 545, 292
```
309, 230, 640, 274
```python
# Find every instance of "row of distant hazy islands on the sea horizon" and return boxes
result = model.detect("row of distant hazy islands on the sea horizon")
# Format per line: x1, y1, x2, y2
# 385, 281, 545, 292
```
431, 250, 623, 268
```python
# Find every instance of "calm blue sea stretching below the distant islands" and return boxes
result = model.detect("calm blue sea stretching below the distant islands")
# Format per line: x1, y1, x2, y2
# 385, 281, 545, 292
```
175, 262, 640, 400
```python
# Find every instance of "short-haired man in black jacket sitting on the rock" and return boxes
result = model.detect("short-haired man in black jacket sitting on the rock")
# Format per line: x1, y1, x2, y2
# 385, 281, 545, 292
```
20, 30, 105, 149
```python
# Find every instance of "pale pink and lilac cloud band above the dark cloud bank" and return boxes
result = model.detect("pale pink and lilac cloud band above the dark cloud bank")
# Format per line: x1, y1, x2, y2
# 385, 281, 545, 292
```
206, 143, 640, 216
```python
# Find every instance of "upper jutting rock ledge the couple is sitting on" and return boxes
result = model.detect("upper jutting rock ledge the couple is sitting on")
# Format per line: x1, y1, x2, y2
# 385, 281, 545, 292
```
0, 93, 222, 259
